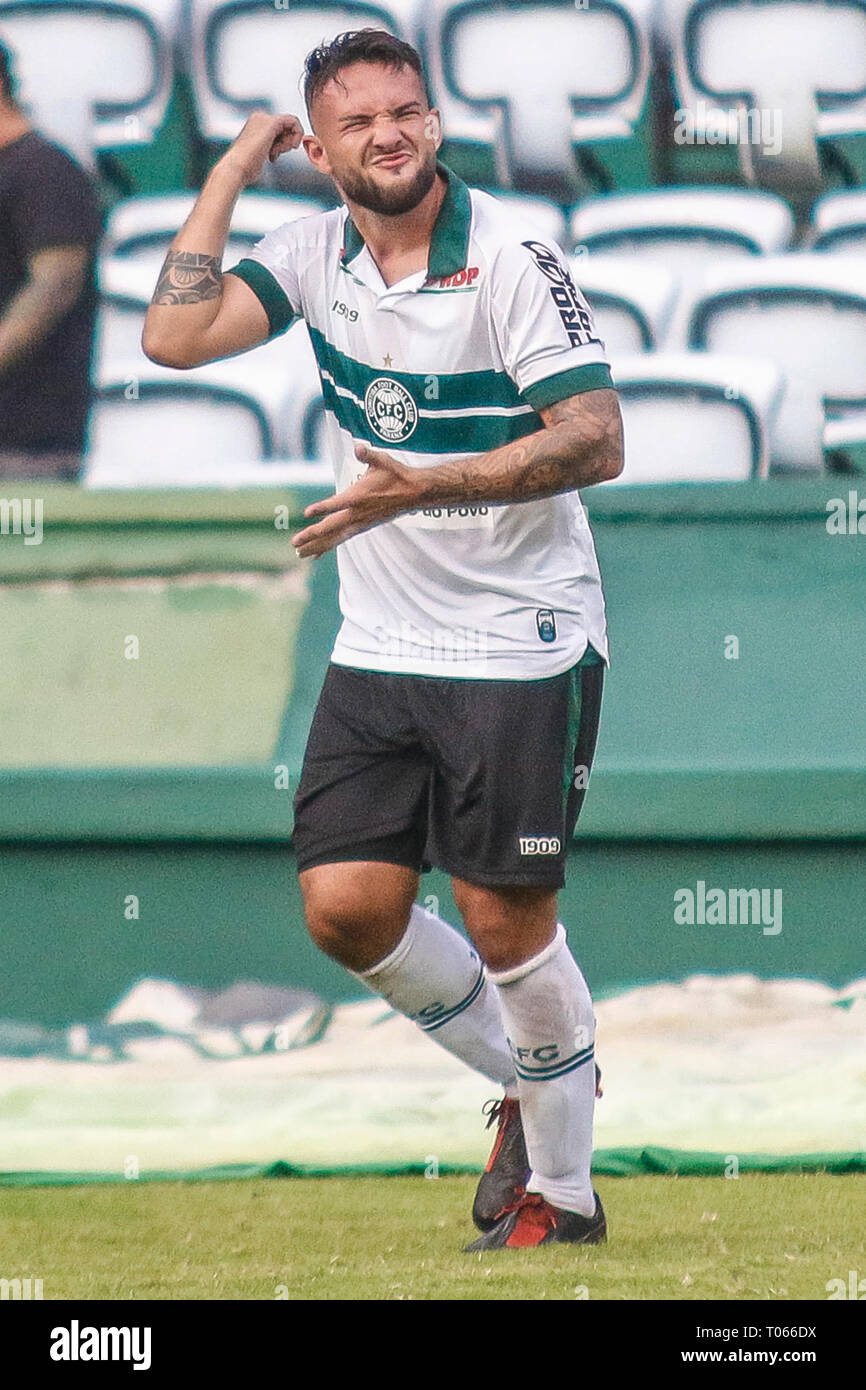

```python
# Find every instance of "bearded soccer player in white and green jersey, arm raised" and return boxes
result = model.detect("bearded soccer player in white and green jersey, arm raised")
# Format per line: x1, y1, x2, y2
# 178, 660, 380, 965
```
143, 29, 621, 1250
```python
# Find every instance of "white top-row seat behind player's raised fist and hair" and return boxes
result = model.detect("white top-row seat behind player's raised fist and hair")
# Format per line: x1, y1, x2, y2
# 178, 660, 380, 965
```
186, 0, 414, 196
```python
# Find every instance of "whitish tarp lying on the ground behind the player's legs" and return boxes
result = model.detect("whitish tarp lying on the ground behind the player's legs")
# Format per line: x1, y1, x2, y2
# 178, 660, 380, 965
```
0, 976, 866, 1176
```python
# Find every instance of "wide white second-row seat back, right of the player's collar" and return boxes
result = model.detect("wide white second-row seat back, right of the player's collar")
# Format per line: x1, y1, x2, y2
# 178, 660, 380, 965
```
569, 188, 794, 261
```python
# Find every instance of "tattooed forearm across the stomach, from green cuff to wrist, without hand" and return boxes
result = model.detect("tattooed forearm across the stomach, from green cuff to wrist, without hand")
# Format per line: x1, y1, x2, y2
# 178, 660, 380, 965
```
419, 388, 623, 506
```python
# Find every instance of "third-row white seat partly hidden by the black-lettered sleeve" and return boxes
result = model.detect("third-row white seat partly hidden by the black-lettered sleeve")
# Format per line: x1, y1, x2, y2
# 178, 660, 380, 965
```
569, 254, 680, 353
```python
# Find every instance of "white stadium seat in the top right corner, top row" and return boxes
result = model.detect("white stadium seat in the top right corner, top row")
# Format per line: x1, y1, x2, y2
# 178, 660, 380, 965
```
659, 0, 866, 193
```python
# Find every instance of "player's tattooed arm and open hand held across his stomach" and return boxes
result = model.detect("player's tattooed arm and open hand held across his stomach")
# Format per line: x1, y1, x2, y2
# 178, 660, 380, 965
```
292, 388, 623, 559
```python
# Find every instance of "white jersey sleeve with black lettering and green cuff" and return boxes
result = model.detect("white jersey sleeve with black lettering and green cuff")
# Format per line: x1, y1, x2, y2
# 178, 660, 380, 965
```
491, 235, 613, 410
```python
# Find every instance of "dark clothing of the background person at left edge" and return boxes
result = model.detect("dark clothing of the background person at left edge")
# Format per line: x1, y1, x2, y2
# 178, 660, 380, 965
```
0, 129, 103, 478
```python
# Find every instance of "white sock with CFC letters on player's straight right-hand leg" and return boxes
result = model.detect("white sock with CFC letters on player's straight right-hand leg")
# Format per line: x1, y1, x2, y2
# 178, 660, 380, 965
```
491, 923, 595, 1216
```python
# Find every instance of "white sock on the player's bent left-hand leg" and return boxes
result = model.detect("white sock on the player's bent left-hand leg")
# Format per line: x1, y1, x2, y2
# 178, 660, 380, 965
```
353, 902, 517, 1095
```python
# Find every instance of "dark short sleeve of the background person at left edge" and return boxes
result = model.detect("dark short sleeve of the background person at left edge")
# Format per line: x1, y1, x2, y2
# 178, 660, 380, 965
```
10, 142, 103, 259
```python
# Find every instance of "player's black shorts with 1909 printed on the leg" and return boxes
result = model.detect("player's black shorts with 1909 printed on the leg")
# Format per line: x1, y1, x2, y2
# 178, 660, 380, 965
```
293, 649, 605, 888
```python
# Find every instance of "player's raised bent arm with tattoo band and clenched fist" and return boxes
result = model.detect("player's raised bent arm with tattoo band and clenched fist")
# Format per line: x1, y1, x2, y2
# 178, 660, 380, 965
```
142, 111, 302, 367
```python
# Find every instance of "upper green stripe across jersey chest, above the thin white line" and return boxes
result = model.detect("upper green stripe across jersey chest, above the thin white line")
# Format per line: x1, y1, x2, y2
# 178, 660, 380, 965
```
307, 325, 538, 411
